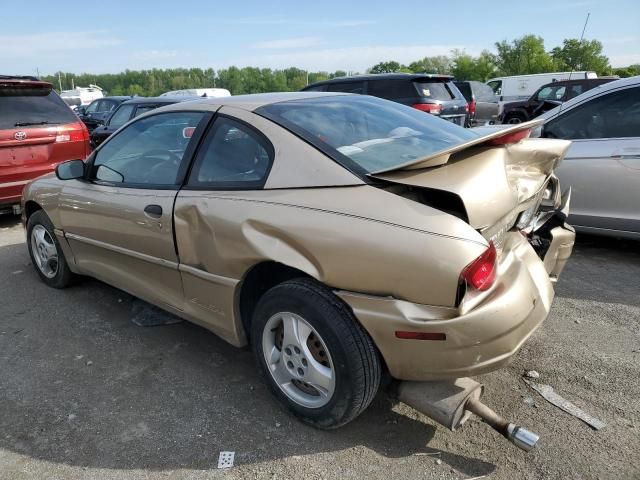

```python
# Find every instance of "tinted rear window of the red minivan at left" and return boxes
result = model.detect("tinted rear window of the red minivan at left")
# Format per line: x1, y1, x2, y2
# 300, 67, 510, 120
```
0, 87, 78, 130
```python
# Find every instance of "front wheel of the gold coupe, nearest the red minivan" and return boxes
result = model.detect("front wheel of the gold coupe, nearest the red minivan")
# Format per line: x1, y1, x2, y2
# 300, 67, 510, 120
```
27, 210, 74, 288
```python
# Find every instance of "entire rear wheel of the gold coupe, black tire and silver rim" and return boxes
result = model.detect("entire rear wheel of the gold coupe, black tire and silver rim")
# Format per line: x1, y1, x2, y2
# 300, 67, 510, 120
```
251, 278, 382, 429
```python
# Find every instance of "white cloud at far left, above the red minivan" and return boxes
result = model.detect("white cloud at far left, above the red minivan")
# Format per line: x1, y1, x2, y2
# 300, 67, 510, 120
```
0, 31, 123, 59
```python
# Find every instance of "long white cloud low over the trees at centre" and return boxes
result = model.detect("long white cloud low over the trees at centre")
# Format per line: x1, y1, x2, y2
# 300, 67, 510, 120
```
219, 45, 482, 73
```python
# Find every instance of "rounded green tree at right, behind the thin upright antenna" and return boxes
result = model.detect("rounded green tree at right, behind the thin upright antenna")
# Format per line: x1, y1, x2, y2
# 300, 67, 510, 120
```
551, 38, 611, 75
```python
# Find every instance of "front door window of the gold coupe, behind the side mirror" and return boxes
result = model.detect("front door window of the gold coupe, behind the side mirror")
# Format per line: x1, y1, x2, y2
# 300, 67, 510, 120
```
91, 112, 204, 186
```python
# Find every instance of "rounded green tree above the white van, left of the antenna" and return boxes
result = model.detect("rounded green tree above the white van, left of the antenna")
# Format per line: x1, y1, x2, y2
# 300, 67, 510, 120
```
495, 35, 554, 75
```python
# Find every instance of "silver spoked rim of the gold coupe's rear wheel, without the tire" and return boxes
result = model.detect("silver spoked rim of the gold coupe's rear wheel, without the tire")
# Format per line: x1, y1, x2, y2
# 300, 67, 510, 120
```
262, 312, 335, 408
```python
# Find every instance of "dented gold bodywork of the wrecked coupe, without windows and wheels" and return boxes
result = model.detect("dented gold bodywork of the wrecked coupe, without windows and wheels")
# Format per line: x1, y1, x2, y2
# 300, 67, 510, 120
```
23, 93, 574, 380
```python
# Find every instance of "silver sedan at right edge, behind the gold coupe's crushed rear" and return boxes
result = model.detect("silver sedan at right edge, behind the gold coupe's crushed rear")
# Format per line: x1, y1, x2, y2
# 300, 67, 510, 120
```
536, 77, 640, 239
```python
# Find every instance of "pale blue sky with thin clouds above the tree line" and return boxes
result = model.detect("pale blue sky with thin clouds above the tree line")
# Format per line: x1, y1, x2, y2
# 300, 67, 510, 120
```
0, 0, 640, 75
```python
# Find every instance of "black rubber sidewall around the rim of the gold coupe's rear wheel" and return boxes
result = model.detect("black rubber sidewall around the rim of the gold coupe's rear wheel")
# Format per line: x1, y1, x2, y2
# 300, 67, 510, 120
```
251, 282, 370, 428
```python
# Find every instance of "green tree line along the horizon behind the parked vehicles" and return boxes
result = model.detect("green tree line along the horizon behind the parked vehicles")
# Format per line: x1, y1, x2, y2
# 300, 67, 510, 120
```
42, 35, 640, 96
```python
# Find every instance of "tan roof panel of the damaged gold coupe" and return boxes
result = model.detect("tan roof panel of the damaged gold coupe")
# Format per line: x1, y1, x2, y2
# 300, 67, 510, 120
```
156, 92, 351, 112
